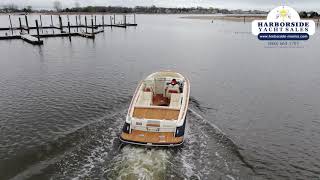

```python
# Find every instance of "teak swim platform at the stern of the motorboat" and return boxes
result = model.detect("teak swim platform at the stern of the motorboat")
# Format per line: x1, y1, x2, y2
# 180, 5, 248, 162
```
121, 130, 183, 144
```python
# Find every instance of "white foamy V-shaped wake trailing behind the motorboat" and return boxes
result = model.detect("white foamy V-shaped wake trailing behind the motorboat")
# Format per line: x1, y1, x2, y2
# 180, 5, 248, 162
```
16, 99, 255, 180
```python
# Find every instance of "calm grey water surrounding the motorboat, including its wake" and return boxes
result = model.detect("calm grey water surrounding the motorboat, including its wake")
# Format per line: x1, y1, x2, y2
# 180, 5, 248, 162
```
0, 15, 320, 180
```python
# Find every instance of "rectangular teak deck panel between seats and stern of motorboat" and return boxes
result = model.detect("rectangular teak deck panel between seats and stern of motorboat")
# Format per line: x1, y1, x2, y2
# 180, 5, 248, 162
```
133, 107, 180, 120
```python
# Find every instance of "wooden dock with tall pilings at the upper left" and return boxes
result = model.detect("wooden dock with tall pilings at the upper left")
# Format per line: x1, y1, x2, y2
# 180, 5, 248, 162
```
0, 14, 137, 45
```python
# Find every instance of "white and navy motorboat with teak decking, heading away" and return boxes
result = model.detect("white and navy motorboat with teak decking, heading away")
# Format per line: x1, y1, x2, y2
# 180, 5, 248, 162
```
120, 71, 190, 146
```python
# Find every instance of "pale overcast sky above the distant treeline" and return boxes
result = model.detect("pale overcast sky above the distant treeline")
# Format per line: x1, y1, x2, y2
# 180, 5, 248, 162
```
0, 0, 320, 11
